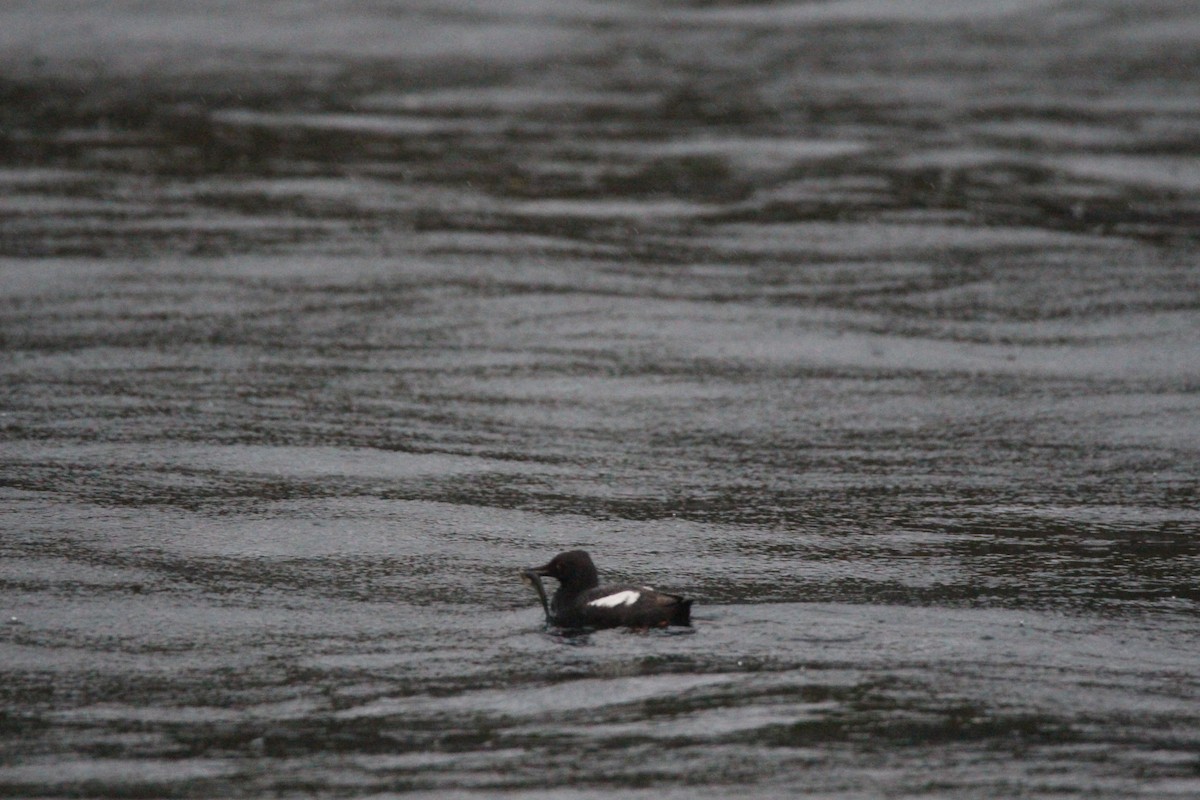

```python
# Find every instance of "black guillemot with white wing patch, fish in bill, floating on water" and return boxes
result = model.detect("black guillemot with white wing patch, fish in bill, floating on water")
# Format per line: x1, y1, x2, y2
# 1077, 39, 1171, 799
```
524, 551, 691, 628
